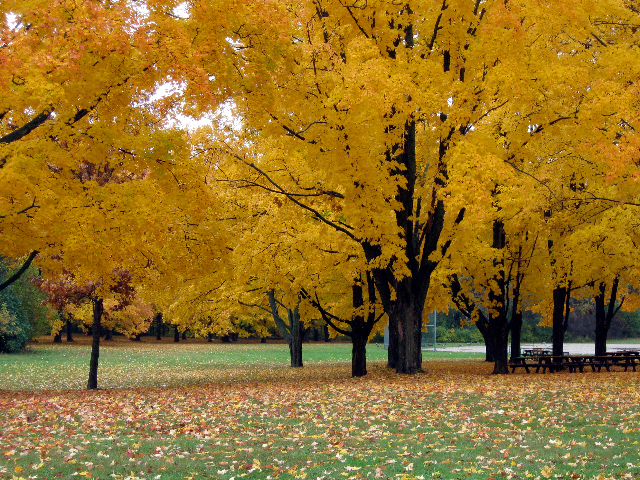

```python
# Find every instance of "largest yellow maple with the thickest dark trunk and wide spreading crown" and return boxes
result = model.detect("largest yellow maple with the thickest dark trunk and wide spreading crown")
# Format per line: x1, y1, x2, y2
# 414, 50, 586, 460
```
175, 1, 634, 373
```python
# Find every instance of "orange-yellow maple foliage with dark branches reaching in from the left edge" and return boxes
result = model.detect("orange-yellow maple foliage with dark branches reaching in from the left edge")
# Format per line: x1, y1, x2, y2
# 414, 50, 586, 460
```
0, 0, 226, 276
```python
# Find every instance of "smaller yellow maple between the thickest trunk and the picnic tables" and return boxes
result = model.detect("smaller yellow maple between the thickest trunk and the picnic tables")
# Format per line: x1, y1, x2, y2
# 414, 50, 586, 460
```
436, 181, 546, 374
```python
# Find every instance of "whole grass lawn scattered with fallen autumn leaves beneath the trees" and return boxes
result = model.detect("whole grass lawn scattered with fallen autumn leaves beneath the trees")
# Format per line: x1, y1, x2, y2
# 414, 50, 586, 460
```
0, 342, 640, 480
